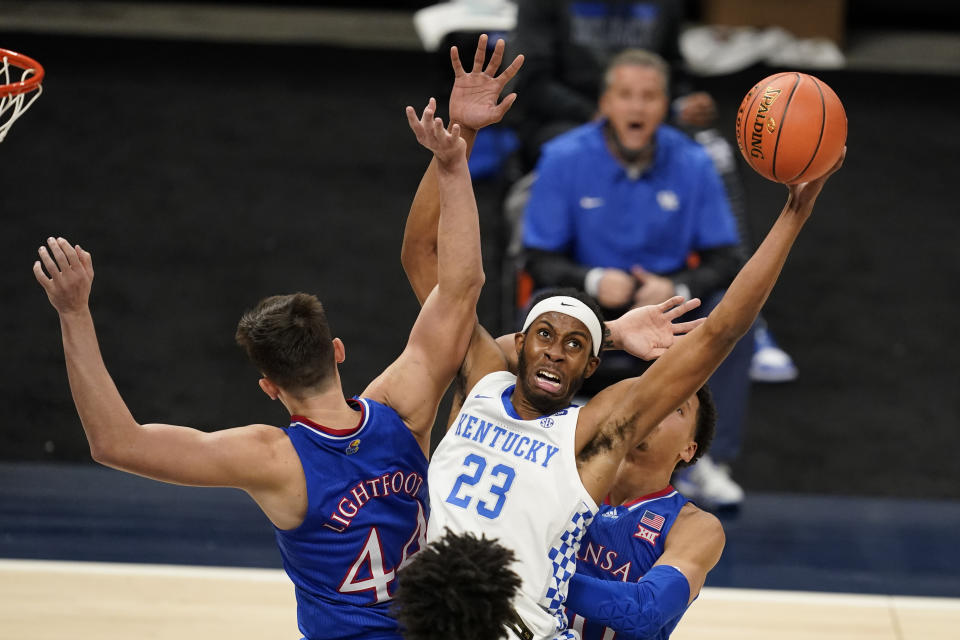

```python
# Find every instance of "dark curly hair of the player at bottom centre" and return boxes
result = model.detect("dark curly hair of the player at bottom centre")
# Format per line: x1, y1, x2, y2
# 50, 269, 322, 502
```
393, 529, 520, 640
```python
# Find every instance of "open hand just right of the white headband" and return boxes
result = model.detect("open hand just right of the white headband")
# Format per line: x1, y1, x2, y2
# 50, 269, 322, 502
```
607, 296, 706, 360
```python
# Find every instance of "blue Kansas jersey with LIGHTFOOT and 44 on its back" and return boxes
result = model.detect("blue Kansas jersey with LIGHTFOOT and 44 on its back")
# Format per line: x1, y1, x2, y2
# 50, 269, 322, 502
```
276, 398, 429, 640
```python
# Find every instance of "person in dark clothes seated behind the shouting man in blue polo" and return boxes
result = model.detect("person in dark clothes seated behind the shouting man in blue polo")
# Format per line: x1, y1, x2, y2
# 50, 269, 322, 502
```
509, 0, 797, 384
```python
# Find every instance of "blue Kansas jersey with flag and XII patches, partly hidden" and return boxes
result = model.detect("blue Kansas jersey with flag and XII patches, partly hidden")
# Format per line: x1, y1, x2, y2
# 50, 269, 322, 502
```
567, 486, 687, 640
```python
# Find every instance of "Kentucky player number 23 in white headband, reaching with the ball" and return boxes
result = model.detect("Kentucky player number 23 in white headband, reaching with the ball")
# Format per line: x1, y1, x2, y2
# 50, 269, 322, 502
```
402, 51, 842, 639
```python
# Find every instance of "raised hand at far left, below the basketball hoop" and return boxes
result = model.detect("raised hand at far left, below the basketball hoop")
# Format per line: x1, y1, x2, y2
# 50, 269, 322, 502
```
33, 237, 93, 314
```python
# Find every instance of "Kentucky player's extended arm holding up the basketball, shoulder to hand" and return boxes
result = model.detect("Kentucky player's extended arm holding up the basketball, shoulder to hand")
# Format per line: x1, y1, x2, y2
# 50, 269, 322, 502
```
577, 154, 845, 497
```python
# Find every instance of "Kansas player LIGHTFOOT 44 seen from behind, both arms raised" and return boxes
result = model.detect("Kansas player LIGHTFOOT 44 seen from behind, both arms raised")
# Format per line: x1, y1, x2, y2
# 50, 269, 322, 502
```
33, 40, 520, 640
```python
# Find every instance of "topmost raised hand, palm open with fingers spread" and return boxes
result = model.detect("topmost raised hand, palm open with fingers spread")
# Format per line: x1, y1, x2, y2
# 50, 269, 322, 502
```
450, 34, 523, 130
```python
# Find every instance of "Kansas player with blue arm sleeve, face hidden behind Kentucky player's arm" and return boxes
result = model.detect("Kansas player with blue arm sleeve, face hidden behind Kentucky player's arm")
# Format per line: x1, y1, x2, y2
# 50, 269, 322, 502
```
567, 387, 724, 640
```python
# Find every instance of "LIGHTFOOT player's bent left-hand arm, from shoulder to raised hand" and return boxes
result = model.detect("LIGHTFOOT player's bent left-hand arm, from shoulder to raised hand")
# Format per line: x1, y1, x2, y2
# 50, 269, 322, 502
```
33, 238, 296, 523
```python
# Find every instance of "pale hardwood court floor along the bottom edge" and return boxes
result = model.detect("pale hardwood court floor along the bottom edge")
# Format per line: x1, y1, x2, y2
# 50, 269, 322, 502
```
0, 560, 960, 640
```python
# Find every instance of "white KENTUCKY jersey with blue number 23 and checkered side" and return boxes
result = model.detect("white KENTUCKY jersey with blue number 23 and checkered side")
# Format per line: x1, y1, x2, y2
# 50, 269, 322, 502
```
427, 371, 597, 640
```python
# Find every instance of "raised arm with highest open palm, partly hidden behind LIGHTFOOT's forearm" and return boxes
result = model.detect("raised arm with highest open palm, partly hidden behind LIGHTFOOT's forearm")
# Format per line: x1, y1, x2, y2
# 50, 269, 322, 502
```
400, 34, 523, 304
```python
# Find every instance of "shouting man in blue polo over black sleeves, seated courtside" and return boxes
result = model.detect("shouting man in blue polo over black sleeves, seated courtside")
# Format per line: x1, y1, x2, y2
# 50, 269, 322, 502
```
523, 50, 752, 507
